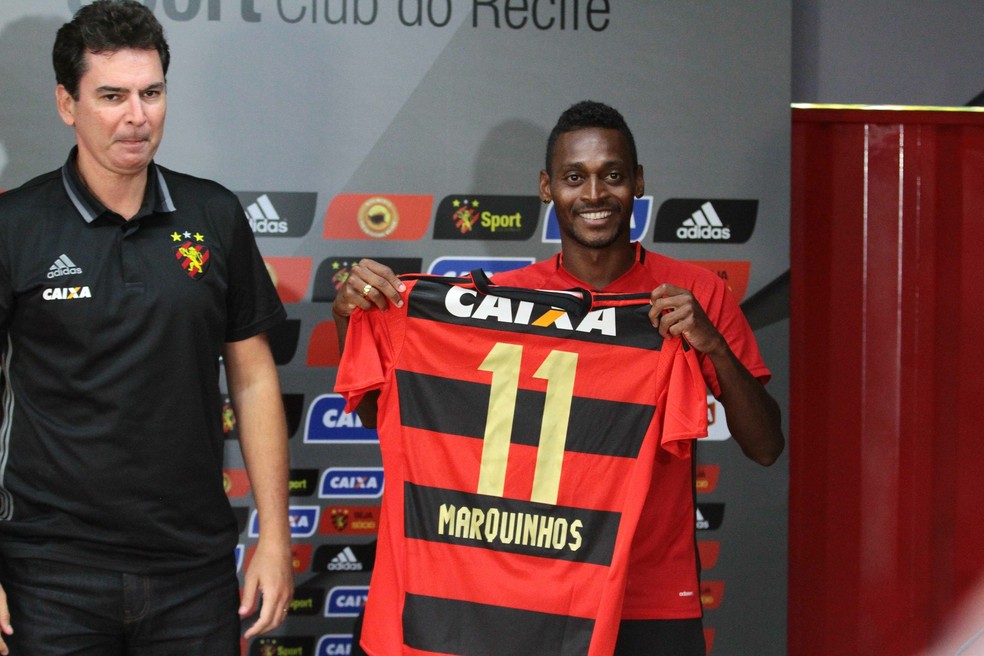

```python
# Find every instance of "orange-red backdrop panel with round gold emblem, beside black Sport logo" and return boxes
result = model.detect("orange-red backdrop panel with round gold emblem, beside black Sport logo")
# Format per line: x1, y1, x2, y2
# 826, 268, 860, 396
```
323, 194, 434, 240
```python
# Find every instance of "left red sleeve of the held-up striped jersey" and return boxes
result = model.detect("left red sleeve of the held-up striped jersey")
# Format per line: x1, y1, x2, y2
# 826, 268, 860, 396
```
335, 309, 392, 412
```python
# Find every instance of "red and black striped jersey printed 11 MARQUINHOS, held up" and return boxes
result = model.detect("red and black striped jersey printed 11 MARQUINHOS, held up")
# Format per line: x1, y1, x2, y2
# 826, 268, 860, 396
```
335, 276, 707, 656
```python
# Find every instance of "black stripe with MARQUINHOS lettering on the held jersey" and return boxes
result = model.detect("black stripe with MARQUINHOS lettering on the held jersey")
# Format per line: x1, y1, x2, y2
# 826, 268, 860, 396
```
403, 483, 621, 566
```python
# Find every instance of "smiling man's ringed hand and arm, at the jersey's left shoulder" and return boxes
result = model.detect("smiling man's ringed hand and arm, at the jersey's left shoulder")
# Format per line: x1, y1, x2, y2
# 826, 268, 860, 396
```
331, 258, 406, 428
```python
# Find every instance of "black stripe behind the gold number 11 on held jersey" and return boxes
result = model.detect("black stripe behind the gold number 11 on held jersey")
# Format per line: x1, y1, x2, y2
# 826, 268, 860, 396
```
396, 370, 656, 458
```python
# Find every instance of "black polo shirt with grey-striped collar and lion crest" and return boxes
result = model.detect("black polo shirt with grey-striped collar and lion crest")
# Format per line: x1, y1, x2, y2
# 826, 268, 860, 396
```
0, 151, 285, 572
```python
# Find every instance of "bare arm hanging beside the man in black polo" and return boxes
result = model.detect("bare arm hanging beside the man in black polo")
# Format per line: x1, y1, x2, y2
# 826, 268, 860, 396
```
224, 334, 294, 638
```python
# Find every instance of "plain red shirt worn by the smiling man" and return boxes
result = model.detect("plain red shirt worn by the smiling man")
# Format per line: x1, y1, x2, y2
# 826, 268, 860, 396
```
493, 244, 771, 619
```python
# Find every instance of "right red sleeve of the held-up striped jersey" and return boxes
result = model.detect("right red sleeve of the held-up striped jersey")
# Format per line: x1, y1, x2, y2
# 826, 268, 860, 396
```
660, 340, 707, 457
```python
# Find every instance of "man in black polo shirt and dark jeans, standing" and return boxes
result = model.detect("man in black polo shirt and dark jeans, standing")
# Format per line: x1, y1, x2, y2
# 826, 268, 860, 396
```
0, 0, 293, 656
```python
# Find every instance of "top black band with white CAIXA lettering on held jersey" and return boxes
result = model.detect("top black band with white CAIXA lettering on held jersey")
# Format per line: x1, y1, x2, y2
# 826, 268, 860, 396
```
407, 280, 663, 357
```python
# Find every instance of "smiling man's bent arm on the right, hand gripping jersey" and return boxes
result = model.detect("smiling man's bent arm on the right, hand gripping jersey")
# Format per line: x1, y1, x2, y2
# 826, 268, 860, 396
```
649, 284, 786, 466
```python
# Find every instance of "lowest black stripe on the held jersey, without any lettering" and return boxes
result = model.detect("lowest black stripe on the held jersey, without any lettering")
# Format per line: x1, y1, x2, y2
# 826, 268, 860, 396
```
403, 594, 594, 656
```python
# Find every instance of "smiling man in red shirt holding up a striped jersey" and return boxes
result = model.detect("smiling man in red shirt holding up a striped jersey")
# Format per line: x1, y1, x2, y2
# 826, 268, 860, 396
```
332, 101, 785, 656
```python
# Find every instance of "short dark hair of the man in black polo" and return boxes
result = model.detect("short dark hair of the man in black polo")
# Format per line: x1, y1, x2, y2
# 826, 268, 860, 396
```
51, 0, 171, 99
